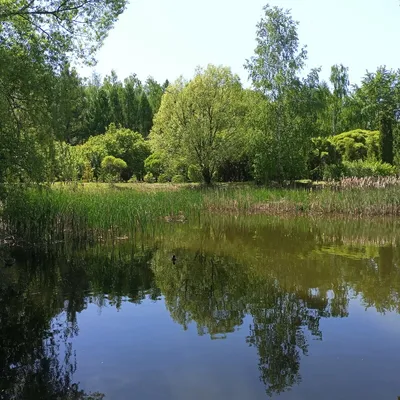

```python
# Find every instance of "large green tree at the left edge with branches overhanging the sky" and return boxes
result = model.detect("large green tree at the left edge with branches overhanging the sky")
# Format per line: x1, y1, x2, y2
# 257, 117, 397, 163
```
0, 0, 126, 181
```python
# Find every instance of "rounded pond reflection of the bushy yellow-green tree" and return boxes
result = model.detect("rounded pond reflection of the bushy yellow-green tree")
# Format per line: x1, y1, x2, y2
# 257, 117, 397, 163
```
156, 252, 246, 338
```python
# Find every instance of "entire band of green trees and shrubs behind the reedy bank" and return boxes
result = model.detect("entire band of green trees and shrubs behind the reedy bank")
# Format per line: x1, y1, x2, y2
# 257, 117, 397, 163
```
0, 0, 400, 183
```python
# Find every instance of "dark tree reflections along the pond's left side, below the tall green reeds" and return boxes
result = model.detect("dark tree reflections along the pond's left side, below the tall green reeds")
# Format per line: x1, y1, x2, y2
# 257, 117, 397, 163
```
0, 242, 155, 400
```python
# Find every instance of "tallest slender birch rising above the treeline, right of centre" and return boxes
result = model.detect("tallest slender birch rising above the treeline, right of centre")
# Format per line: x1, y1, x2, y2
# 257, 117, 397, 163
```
245, 5, 308, 181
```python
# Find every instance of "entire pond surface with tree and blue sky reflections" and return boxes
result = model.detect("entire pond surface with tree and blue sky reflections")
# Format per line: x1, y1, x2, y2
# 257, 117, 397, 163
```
0, 217, 400, 400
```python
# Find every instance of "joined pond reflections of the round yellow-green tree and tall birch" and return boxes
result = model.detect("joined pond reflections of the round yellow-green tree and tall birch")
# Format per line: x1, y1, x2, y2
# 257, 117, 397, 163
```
155, 251, 321, 395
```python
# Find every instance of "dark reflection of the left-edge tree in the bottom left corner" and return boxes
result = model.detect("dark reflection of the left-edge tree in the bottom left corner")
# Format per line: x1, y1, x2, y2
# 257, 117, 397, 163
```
0, 266, 79, 399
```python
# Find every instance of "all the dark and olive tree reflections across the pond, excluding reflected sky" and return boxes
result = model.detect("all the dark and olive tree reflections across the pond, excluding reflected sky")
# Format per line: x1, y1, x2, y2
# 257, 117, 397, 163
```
0, 219, 400, 400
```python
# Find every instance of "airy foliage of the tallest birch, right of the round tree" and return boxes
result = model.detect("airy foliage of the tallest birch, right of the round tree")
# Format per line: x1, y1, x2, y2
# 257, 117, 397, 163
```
245, 6, 320, 182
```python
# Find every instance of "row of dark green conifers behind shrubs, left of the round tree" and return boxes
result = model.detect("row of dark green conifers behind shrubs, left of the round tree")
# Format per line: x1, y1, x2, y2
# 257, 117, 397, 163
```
55, 65, 169, 145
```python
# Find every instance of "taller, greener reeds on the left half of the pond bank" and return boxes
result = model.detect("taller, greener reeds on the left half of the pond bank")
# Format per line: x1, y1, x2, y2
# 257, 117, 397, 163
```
2, 187, 201, 242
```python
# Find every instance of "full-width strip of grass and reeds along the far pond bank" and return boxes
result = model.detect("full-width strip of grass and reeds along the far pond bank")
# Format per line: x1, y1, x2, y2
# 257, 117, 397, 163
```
2, 180, 400, 242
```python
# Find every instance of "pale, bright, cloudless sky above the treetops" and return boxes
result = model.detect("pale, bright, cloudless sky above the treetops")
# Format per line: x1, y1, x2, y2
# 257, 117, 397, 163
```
81, 0, 400, 86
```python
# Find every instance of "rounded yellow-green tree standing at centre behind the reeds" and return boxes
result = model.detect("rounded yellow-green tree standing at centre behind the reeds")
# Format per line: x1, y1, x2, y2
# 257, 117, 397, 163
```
150, 65, 243, 184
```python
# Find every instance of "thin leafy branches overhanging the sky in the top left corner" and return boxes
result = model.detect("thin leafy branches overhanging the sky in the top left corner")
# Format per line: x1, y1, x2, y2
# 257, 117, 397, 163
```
0, 0, 126, 65
